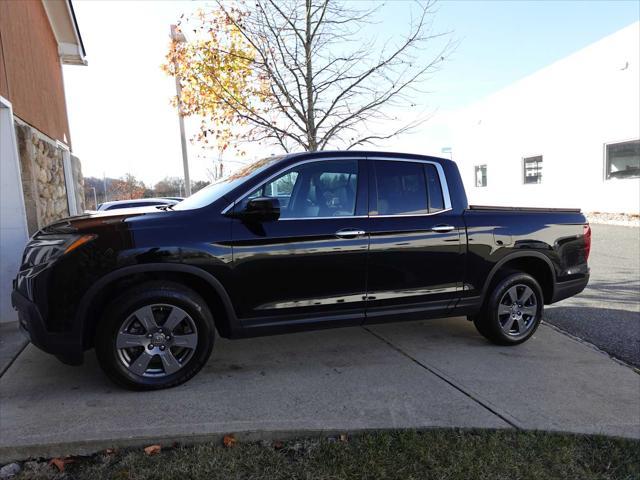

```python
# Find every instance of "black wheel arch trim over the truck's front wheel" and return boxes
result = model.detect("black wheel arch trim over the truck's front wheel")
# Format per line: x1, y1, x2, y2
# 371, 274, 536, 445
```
75, 263, 242, 349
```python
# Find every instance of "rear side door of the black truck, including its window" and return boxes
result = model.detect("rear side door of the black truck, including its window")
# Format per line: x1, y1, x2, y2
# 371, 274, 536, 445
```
367, 161, 464, 322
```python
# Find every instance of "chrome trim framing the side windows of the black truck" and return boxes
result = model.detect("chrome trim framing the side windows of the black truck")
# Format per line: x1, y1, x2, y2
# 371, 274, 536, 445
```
222, 157, 453, 220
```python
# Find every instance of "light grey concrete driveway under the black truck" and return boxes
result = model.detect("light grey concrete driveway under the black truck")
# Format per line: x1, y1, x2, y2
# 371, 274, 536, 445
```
0, 318, 640, 462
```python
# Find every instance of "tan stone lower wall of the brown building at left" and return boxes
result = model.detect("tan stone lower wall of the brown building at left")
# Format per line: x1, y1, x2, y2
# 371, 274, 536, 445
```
16, 119, 84, 235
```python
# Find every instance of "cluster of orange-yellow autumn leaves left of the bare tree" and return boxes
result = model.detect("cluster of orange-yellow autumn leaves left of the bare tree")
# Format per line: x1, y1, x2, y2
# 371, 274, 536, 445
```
163, 4, 271, 153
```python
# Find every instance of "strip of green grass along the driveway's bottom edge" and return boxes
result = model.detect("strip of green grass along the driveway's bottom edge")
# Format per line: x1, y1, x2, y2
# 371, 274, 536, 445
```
17, 430, 640, 480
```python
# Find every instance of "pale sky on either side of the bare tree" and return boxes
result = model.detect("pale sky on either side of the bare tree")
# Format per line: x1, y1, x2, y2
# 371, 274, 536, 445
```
64, 0, 640, 185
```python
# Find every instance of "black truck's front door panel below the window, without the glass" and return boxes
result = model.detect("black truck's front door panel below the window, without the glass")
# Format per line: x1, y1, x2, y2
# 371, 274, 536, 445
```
233, 218, 368, 317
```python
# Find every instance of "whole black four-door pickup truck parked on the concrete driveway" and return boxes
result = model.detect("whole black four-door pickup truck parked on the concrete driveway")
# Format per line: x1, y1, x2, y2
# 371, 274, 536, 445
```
12, 152, 591, 389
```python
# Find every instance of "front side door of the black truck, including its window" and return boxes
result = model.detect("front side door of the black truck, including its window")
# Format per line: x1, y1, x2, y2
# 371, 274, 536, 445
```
232, 160, 369, 329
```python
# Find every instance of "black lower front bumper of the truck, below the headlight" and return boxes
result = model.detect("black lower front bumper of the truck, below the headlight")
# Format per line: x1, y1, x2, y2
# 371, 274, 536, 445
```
11, 290, 84, 365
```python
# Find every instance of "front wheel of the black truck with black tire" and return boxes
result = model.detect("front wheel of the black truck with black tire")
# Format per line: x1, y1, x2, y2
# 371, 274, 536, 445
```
95, 281, 215, 390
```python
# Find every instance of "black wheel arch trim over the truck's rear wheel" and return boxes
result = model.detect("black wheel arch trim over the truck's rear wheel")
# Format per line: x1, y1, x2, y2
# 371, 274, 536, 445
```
482, 251, 556, 304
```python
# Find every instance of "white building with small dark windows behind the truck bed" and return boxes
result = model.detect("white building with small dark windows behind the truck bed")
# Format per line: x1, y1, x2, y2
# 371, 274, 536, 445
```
446, 23, 640, 214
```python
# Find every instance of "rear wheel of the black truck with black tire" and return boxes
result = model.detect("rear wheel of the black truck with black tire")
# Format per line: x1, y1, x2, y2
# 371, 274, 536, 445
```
473, 272, 544, 346
